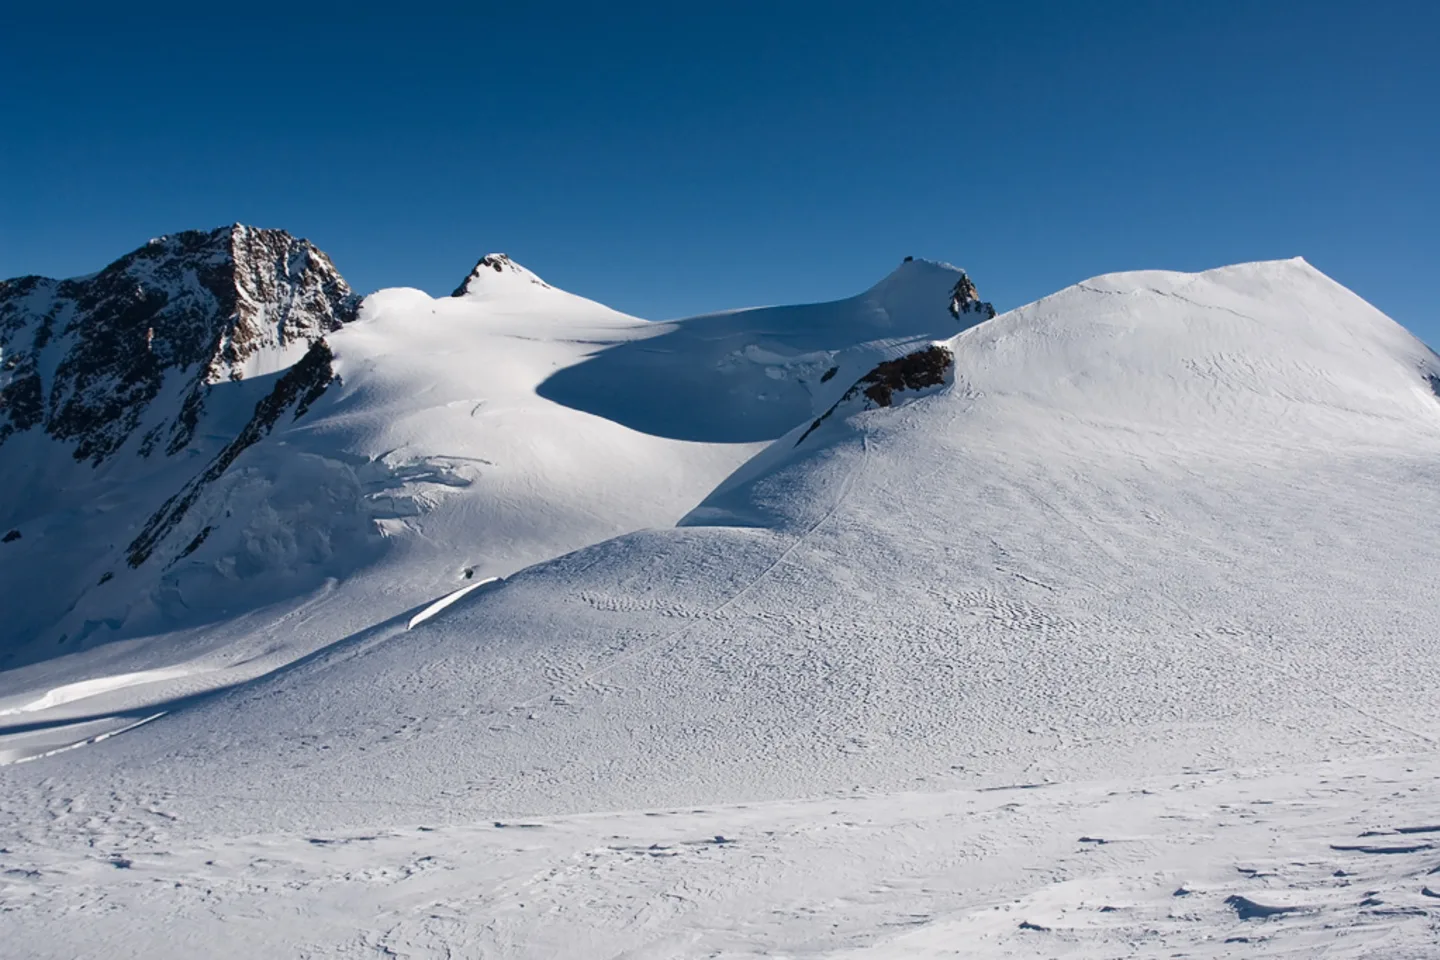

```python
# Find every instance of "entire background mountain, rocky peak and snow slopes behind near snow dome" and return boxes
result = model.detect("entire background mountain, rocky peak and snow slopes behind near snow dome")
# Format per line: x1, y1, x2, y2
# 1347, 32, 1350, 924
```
0, 236, 978, 719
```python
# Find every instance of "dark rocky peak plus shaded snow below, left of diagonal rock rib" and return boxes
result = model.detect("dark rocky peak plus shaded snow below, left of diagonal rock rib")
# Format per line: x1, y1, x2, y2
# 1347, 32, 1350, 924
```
0, 225, 359, 665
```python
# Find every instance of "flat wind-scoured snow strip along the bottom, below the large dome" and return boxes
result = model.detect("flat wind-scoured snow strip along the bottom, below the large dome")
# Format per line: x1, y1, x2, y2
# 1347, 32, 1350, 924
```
0, 754, 1440, 960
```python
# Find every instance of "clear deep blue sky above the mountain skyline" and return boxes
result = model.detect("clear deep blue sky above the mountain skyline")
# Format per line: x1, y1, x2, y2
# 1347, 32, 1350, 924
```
0, 0, 1440, 344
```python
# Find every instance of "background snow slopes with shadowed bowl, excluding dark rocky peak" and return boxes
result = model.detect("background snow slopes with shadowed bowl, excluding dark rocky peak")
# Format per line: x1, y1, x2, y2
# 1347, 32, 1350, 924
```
0, 255, 973, 756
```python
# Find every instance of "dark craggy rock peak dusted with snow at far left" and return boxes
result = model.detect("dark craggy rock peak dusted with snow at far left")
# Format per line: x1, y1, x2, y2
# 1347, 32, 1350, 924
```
0, 225, 359, 463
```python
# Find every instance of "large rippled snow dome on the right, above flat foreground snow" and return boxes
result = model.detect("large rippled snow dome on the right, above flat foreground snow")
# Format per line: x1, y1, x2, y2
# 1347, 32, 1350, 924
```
50, 262, 1440, 829
